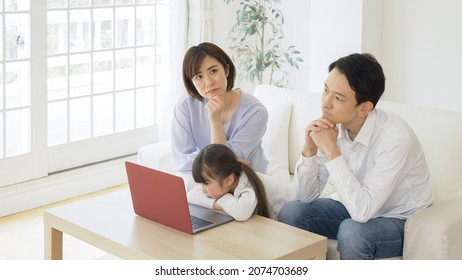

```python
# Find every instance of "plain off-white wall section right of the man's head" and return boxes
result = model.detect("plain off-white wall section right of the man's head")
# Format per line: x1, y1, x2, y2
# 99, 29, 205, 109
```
383, 0, 462, 112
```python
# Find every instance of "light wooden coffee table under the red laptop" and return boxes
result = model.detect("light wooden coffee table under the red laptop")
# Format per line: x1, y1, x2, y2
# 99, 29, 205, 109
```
44, 190, 327, 260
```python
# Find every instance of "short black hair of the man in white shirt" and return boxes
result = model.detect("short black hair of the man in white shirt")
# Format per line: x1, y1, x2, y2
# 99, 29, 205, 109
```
329, 53, 385, 107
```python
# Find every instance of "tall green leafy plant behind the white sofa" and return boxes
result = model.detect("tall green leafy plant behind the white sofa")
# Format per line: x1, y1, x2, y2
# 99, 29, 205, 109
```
224, 0, 303, 87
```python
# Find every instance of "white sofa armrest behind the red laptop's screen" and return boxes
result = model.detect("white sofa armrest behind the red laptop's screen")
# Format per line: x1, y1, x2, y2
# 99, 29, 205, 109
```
138, 140, 176, 174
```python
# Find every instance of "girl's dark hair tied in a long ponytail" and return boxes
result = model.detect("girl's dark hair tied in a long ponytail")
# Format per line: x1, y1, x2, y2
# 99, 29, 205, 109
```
192, 144, 271, 218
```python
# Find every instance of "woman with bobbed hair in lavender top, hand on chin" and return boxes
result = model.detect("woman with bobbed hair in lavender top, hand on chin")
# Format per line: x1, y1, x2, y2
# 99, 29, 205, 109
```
172, 43, 268, 190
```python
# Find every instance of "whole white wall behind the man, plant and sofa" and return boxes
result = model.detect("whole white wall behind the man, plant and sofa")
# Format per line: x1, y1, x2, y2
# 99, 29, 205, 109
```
213, 0, 462, 112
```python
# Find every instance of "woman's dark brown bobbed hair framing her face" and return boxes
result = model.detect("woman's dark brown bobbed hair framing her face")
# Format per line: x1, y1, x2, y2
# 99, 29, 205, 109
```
182, 42, 236, 101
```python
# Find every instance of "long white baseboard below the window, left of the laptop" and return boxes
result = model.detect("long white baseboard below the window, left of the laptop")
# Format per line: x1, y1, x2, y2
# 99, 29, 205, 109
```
0, 155, 136, 217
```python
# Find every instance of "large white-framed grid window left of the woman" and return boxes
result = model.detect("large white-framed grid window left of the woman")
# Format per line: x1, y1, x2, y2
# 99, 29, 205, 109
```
0, 0, 169, 186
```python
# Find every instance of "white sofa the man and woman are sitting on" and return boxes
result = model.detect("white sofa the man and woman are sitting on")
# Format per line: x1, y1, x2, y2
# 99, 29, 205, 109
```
138, 85, 462, 259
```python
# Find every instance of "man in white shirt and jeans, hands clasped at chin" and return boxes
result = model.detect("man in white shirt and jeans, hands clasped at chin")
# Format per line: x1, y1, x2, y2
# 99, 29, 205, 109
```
278, 54, 432, 259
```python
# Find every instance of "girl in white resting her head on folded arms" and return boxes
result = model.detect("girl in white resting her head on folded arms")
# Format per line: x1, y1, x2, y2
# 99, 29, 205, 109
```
188, 144, 271, 221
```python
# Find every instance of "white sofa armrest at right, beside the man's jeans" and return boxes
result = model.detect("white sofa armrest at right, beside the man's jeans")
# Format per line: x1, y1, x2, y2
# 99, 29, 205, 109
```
403, 192, 462, 260
